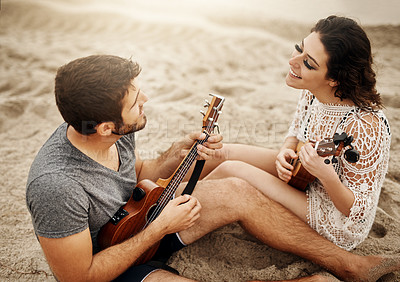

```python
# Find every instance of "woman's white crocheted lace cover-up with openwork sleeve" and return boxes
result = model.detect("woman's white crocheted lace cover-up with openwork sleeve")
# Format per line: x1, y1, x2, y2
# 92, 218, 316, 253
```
287, 90, 391, 250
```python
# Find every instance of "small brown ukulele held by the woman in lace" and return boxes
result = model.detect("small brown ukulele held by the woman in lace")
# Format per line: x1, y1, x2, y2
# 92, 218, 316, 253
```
288, 132, 360, 191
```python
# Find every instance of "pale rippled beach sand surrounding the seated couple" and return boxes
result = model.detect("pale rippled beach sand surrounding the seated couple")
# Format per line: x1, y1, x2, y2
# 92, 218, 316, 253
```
0, 0, 400, 281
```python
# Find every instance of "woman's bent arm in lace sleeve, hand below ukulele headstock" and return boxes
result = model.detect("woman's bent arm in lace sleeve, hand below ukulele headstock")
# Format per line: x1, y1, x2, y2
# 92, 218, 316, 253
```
299, 112, 390, 217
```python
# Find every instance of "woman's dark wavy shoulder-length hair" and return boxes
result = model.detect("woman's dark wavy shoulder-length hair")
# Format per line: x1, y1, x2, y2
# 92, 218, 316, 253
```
311, 16, 383, 109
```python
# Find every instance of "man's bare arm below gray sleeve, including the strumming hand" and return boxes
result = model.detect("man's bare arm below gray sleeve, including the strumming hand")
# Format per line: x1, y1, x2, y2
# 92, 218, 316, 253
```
39, 195, 201, 281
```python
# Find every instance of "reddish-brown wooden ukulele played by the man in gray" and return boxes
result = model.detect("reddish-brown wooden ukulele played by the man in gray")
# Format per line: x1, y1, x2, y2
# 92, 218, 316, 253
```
98, 94, 225, 265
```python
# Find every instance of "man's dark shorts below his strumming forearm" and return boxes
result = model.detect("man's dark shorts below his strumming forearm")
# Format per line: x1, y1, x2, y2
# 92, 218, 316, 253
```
114, 233, 185, 282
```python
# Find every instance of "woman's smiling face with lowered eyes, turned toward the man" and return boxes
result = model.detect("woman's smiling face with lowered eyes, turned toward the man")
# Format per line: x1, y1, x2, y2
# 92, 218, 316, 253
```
286, 32, 336, 95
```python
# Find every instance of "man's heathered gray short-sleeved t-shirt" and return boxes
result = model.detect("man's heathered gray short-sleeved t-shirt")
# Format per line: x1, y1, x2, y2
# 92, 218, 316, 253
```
26, 123, 136, 253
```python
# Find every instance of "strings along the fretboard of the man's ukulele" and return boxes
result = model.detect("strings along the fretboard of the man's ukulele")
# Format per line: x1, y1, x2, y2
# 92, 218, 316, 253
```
143, 104, 218, 226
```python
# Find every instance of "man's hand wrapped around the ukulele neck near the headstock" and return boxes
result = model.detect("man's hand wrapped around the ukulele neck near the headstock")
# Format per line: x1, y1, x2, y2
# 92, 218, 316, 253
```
181, 132, 223, 160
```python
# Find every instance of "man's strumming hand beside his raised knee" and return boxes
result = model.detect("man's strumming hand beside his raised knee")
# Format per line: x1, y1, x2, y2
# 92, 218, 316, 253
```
154, 195, 201, 234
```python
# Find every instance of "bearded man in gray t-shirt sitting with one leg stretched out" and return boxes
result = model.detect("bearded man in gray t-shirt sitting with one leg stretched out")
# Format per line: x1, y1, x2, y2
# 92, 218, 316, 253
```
26, 55, 400, 281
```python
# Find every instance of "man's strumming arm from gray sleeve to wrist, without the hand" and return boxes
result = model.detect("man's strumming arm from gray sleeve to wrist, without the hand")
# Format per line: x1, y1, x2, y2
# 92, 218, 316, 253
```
39, 226, 162, 281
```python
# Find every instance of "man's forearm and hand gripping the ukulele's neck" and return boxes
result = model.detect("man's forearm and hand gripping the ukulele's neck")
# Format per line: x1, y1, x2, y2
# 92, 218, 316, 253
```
135, 132, 222, 181
